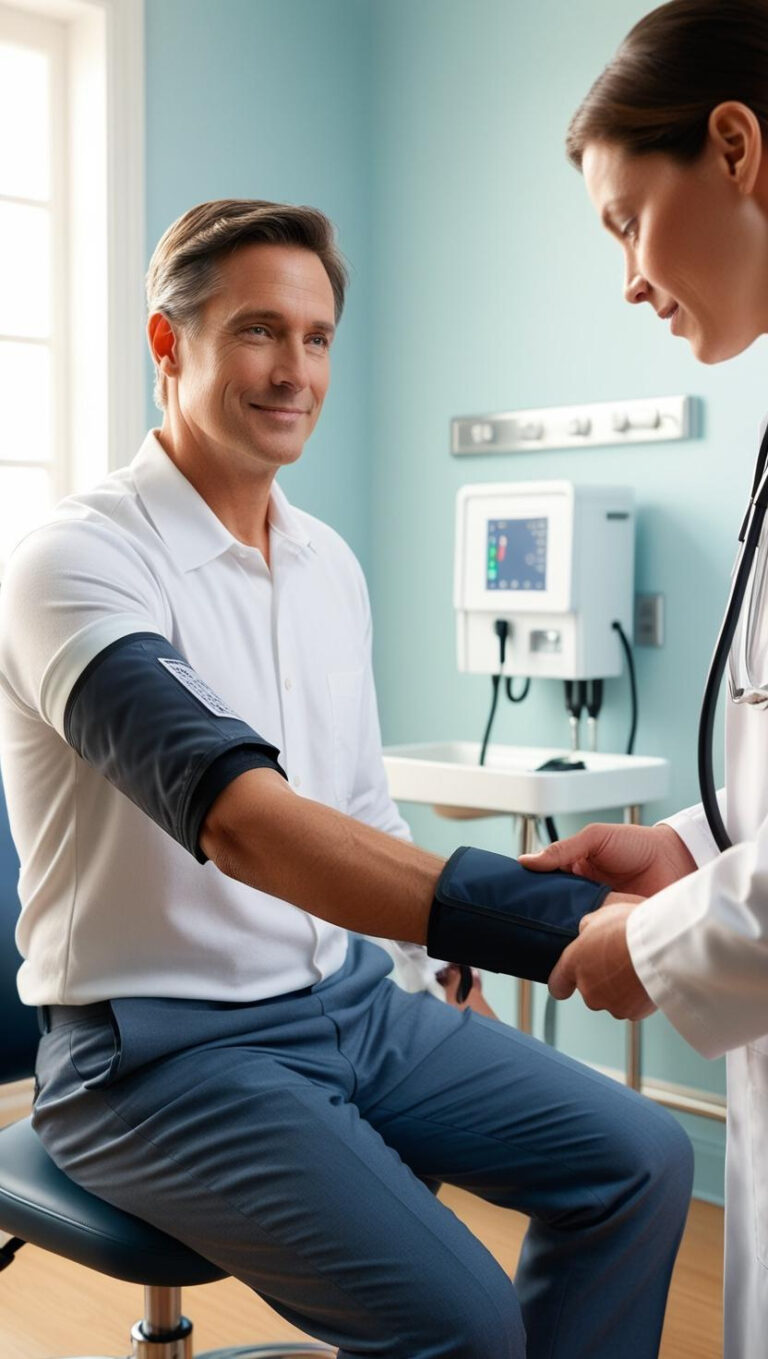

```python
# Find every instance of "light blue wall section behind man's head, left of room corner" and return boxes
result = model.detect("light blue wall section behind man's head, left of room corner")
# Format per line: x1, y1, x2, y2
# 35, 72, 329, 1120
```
145, 0, 371, 565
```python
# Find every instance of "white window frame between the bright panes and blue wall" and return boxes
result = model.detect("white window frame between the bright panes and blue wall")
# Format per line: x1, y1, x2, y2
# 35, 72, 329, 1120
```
0, 0, 147, 519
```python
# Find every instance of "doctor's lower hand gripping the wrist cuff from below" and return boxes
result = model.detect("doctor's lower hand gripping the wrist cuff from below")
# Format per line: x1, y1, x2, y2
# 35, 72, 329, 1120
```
548, 893, 657, 1019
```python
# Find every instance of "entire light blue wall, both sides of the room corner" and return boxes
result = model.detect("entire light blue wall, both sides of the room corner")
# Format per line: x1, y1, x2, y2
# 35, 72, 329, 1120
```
147, 0, 768, 1197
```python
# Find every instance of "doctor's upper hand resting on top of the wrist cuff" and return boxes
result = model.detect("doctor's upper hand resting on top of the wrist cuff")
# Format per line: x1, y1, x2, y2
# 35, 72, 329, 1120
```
519, 822, 696, 897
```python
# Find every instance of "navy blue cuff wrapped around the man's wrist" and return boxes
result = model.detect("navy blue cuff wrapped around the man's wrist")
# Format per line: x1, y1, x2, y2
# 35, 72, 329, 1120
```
427, 847, 610, 981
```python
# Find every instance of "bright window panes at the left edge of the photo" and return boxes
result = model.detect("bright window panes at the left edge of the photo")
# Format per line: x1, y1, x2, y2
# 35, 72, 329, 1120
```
0, 10, 69, 569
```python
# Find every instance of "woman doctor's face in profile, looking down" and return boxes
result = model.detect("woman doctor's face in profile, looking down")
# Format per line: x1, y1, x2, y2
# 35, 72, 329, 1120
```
582, 141, 768, 363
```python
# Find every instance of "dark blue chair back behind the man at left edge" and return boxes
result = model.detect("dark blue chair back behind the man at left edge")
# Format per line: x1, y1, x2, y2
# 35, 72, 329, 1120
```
0, 786, 39, 1082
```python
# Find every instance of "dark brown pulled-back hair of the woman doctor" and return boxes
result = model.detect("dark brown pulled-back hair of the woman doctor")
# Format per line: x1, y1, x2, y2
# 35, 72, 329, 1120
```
565, 0, 768, 170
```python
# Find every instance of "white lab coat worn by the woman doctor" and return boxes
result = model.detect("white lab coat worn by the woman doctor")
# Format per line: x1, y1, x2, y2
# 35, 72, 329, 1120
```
628, 587, 768, 1359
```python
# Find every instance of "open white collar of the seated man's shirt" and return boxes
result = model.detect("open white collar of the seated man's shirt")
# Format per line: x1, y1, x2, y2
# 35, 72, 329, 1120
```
130, 429, 314, 571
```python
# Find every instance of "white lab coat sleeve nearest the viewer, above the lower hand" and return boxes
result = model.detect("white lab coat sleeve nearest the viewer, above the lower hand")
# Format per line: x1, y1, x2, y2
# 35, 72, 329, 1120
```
627, 799, 768, 1057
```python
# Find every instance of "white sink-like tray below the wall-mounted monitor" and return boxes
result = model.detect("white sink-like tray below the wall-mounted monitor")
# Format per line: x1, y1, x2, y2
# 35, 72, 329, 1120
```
383, 741, 670, 817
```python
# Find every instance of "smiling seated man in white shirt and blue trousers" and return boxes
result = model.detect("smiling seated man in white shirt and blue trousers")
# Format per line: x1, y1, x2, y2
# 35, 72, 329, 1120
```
0, 200, 691, 1359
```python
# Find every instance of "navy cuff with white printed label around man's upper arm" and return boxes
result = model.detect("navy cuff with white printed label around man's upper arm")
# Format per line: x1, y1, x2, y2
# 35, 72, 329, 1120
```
64, 632, 285, 863
